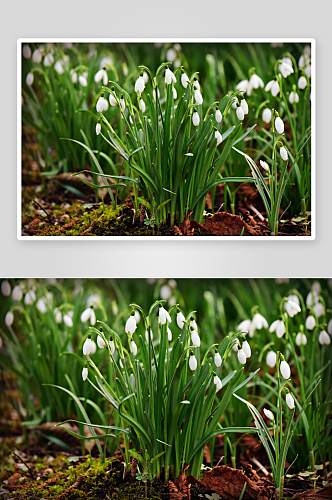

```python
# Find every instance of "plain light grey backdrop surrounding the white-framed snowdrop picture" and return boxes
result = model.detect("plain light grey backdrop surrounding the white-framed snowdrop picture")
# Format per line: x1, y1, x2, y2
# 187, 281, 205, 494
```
0, 0, 332, 277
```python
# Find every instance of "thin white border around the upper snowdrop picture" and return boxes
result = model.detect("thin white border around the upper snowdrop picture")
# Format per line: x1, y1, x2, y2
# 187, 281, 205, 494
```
17, 38, 316, 243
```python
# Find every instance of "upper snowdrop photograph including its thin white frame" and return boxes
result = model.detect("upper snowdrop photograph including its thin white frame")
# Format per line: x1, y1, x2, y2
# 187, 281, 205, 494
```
17, 38, 316, 241
